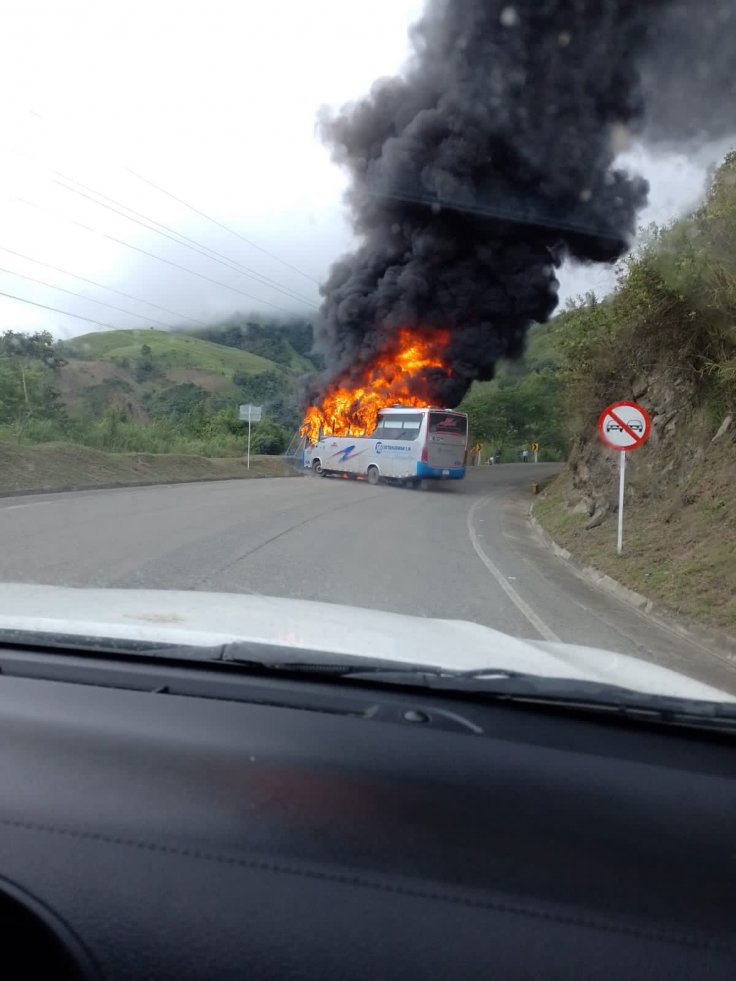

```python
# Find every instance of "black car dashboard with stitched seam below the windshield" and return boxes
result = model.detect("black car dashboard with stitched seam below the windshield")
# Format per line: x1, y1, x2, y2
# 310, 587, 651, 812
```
0, 648, 736, 981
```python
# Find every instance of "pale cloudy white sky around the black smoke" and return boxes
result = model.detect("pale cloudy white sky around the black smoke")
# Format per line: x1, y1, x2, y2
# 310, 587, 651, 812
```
0, 0, 727, 337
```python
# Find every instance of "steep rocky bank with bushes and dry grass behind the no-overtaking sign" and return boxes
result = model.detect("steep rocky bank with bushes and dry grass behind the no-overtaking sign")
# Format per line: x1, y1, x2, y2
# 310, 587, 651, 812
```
535, 152, 736, 633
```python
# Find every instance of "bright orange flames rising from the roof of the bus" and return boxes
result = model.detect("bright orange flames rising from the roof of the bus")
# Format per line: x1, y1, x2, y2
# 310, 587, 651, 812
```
301, 327, 450, 443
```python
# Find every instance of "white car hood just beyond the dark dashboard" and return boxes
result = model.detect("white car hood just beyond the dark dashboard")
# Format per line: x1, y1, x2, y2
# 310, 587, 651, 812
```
0, 583, 736, 702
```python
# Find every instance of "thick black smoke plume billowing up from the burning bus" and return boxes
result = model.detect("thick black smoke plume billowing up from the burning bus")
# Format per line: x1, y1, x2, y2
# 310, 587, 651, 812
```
311, 0, 736, 406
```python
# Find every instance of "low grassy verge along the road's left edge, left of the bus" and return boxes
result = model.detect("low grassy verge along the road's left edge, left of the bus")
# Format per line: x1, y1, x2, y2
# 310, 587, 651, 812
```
0, 443, 296, 495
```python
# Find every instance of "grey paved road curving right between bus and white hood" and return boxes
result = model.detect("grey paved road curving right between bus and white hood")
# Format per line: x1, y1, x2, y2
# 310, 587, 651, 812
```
0, 464, 736, 691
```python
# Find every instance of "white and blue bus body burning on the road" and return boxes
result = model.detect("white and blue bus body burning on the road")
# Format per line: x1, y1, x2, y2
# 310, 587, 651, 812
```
304, 406, 468, 487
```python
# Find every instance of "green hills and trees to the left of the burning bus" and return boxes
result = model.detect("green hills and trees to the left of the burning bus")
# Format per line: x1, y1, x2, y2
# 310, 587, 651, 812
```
0, 317, 316, 457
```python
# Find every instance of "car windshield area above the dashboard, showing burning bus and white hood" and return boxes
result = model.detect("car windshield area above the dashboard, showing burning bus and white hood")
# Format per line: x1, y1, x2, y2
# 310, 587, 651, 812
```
0, 0, 736, 702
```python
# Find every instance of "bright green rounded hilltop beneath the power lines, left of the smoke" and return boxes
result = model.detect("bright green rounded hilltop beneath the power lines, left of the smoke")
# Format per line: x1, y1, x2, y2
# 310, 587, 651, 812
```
64, 330, 278, 375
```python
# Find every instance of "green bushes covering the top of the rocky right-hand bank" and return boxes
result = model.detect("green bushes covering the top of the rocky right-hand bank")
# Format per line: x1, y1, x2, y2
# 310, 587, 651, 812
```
553, 152, 736, 439
